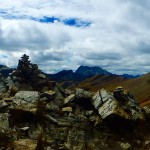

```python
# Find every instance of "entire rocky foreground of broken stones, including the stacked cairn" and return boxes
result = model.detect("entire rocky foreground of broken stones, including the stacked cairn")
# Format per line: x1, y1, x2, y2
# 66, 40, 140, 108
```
0, 55, 150, 150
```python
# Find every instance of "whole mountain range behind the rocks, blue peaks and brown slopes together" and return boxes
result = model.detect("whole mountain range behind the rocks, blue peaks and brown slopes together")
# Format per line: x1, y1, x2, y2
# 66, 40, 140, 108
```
0, 65, 150, 101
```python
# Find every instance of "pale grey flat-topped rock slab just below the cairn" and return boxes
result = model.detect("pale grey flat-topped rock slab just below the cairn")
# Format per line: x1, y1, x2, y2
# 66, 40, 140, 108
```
15, 91, 40, 103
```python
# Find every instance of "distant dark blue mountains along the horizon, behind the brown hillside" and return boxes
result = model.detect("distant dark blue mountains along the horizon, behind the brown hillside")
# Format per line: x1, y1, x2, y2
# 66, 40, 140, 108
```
0, 65, 140, 81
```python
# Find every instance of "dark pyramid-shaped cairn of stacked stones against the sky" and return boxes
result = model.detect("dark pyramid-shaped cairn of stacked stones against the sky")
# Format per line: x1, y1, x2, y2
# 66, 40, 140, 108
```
11, 54, 49, 90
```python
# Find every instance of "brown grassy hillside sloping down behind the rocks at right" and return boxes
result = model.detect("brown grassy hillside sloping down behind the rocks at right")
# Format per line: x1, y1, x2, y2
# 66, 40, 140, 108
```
78, 73, 150, 101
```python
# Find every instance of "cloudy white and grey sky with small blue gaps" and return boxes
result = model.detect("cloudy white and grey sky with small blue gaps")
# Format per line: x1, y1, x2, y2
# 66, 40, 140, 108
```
0, 0, 150, 75
